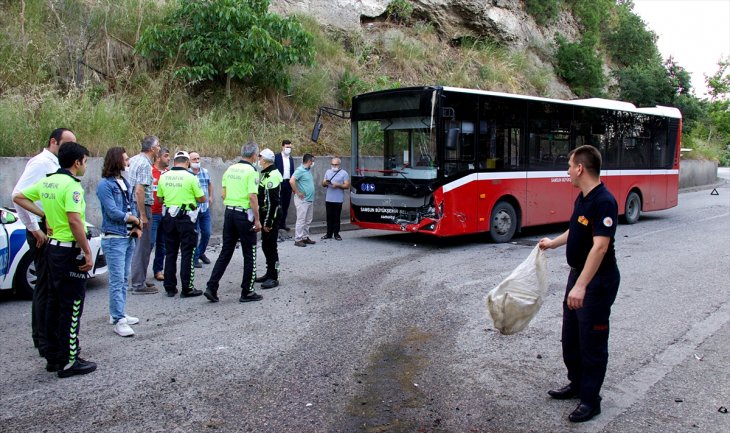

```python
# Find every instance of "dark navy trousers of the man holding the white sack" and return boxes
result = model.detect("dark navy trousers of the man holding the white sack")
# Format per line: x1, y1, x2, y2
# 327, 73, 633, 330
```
562, 267, 621, 404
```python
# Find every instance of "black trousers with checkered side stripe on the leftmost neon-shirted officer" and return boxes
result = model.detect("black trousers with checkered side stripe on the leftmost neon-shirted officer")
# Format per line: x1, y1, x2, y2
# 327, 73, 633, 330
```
46, 244, 89, 365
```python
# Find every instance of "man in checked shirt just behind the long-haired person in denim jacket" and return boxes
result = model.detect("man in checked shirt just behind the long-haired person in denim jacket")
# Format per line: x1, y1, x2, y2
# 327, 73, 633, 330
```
129, 135, 160, 295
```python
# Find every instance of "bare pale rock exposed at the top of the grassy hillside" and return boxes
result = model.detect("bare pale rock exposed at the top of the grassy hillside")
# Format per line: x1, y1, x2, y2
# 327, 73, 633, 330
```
271, 0, 579, 99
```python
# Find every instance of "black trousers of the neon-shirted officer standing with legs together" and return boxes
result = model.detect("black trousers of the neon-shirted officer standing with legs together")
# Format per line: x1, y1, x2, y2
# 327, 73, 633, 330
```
162, 212, 198, 293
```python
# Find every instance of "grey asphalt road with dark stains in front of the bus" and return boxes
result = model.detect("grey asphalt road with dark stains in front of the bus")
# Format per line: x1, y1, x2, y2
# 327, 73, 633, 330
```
0, 181, 730, 433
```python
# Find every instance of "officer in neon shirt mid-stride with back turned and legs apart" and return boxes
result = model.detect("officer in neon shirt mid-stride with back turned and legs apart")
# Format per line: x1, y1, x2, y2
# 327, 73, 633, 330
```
205, 141, 264, 302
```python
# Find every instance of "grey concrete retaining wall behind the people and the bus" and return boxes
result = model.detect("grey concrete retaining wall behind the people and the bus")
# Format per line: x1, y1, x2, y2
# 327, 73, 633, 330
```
0, 156, 717, 233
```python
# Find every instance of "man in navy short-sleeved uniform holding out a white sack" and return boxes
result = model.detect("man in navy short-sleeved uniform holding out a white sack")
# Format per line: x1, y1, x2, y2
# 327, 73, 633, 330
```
538, 145, 621, 422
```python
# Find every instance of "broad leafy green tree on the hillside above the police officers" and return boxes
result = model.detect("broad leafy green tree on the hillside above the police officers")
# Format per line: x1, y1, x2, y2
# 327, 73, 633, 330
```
136, 0, 314, 96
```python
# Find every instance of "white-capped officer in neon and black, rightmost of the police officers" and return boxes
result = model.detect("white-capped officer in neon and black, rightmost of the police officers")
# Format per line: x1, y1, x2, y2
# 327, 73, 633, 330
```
256, 149, 283, 289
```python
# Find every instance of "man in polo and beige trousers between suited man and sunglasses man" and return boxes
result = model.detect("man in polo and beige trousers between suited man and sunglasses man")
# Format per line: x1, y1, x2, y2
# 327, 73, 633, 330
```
289, 153, 316, 247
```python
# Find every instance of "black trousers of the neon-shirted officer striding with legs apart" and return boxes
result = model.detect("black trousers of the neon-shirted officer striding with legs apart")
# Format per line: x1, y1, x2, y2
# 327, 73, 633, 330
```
208, 209, 256, 296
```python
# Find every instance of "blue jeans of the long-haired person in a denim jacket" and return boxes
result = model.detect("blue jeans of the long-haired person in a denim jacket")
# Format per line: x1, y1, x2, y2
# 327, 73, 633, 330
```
101, 238, 135, 323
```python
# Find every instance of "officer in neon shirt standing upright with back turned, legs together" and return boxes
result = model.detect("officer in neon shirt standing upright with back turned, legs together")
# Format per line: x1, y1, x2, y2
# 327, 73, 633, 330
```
157, 150, 206, 298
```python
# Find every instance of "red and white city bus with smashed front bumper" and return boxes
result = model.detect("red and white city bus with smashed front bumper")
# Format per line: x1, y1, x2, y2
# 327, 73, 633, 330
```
350, 86, 682, 242
